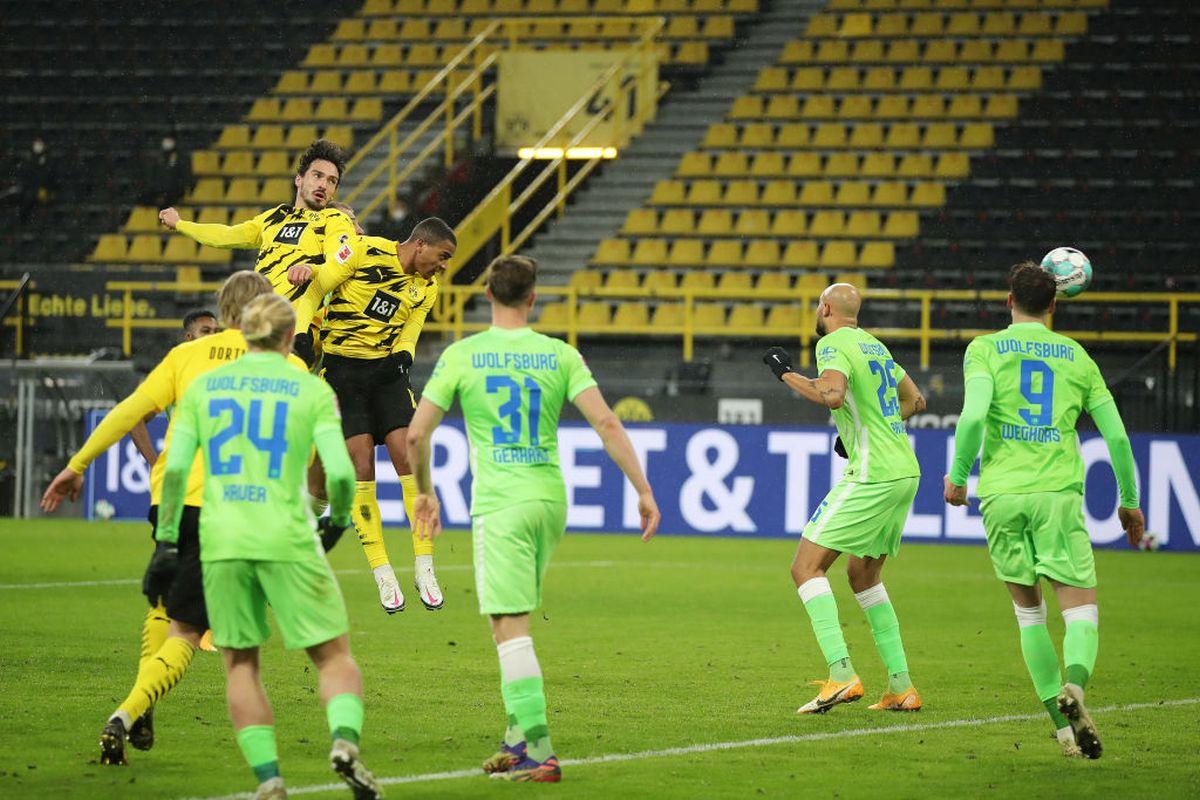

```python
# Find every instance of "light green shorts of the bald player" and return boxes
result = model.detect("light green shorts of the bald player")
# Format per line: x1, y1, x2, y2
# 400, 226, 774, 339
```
802, 477, 920, 558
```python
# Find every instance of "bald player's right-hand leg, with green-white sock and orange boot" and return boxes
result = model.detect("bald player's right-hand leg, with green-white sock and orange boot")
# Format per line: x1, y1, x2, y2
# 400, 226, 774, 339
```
846, 555, 920, 711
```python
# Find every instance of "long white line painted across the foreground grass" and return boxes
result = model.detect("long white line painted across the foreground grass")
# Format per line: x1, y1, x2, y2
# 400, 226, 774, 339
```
187, 697, 1200, 800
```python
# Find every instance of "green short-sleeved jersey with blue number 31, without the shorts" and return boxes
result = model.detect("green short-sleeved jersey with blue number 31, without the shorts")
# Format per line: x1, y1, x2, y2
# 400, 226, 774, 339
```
421, 327, 596, 516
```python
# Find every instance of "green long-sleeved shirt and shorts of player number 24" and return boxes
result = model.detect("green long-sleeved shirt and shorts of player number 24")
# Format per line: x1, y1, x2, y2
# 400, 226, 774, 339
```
158, 353, 354, 649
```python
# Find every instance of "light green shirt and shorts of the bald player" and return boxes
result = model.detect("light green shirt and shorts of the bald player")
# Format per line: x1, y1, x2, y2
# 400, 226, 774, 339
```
803, 327, 920, 558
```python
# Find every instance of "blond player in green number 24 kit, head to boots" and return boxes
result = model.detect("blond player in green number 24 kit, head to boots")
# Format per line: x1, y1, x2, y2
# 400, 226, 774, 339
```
157, 294, 382, 799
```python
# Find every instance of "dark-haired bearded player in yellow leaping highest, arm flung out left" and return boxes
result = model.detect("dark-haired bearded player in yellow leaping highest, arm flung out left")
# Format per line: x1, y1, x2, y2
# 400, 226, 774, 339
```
158, 139, 354, 331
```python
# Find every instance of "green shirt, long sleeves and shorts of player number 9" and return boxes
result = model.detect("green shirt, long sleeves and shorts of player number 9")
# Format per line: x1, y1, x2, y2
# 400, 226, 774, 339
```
950, 323, 1138, 588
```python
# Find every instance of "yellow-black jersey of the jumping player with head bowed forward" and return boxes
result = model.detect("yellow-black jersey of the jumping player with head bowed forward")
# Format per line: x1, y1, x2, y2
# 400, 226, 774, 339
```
320, 236, 438, 359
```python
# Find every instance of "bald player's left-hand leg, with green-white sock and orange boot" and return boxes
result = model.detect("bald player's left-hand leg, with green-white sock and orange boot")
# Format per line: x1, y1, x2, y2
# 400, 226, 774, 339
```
792, 537, 863, 714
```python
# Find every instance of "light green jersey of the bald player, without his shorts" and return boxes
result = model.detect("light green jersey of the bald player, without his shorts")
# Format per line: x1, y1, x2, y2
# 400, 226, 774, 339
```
816, 327, 920, 483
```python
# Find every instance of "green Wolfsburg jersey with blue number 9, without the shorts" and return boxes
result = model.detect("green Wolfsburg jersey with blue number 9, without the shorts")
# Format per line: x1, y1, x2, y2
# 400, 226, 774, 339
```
962, 323, 1112, 497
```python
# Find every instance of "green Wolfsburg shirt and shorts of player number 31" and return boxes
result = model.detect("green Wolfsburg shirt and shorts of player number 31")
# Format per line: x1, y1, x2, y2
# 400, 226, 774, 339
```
422, 327, 596, 614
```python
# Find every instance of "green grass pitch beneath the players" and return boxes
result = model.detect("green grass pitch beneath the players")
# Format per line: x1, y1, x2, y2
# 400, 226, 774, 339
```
0, 521, 1200, 800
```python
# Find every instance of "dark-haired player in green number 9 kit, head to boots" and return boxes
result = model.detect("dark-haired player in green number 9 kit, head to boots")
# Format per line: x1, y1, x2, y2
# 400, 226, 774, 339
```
946, 261, 1145, 758
